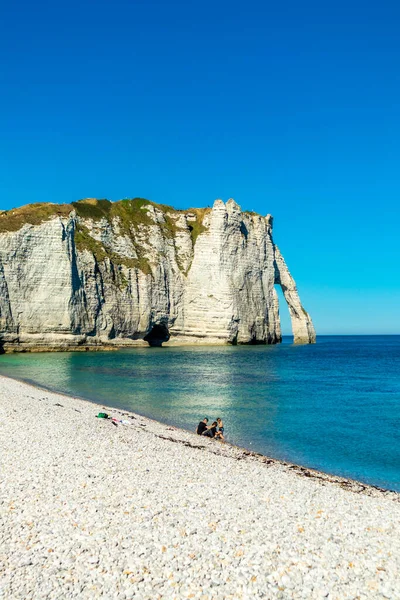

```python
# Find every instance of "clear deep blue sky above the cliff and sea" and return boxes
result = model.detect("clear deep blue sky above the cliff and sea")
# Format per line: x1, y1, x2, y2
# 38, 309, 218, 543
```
0, 0, 400, 334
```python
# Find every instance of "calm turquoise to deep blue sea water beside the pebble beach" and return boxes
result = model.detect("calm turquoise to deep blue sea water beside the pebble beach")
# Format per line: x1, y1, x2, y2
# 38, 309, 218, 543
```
0, 336, 400, 491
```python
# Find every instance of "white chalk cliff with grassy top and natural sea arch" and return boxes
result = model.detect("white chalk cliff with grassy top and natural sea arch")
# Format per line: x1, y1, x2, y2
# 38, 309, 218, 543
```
0, 199, 315, 351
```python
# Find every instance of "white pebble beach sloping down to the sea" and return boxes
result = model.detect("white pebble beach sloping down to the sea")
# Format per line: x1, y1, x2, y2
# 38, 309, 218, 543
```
0, 377, 400, 600
